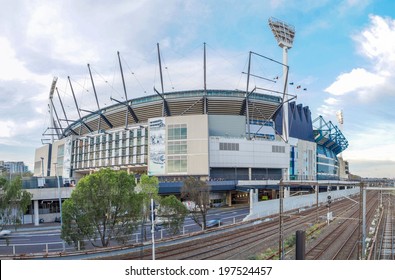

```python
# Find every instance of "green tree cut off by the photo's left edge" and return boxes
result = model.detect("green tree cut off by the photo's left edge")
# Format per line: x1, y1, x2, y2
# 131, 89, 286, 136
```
0, 176, 32, 229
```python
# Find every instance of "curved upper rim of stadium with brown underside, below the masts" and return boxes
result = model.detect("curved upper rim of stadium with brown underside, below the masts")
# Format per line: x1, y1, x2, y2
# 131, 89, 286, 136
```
62, 90, 281, 137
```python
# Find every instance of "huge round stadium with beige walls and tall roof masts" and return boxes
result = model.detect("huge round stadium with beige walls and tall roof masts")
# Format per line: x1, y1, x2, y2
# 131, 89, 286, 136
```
24, 18, 348, 223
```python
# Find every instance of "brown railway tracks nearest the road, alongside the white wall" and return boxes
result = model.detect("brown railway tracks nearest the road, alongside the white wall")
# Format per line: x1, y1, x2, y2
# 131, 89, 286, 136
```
101, 195, 362, 260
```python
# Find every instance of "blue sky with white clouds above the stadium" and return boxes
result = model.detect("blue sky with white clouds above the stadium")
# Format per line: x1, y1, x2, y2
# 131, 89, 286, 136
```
0, 0, 395, 178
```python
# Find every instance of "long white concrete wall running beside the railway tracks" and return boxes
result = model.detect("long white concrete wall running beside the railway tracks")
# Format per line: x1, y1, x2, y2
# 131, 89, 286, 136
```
244, 188, 359, 221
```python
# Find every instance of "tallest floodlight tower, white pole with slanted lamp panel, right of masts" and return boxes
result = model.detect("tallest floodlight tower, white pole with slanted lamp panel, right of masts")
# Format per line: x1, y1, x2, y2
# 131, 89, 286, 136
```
269, 17, 295, 143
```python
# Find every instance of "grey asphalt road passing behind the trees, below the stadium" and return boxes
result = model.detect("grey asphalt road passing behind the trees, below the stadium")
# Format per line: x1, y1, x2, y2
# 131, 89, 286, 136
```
0, 205, 249, 259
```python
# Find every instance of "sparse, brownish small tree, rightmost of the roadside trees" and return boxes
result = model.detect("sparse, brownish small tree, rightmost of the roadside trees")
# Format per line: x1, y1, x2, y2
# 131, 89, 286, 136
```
181, 177, 210, 229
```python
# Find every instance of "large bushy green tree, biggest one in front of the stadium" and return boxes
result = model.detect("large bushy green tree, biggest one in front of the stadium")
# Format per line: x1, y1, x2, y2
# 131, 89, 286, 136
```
61, 169, 142, 247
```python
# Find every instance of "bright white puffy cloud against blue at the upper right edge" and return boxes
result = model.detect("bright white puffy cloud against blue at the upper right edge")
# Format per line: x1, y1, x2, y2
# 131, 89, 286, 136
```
324, 14, 395, 108
